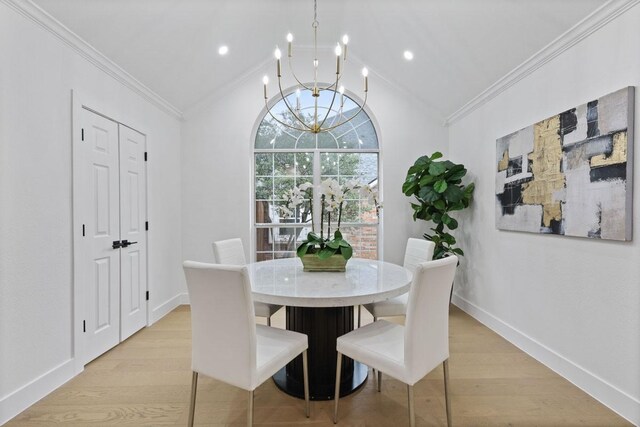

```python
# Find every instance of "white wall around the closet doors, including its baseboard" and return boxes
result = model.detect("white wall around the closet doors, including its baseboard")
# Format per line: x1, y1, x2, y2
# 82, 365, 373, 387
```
0, 2, 183, 424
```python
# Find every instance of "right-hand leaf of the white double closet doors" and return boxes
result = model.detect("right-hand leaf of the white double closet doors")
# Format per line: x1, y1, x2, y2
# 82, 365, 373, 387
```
120, 125, 147, 340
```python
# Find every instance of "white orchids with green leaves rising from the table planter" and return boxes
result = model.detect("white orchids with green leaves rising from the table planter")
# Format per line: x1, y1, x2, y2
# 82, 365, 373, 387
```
280, 178, 382, 260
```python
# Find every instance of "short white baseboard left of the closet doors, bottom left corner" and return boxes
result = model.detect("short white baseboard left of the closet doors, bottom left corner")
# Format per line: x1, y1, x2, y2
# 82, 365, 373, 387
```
0, 359, 76, 425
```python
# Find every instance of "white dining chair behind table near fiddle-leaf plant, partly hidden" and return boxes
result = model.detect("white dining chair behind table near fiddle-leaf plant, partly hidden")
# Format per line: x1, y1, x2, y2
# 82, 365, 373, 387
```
358, 238, 436, 327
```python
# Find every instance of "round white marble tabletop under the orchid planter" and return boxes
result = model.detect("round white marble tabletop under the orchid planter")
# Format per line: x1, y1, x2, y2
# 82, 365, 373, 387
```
247, 258, 412, 307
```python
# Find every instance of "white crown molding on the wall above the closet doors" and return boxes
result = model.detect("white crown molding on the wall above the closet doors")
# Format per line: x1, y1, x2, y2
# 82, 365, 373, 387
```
0, 0, 183, 120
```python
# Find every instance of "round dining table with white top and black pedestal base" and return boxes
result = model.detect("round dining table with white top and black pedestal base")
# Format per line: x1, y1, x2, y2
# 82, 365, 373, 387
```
247, 258, 412, 400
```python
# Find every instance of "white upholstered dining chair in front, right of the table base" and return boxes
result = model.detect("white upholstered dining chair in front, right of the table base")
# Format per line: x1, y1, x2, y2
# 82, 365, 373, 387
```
333, 256, 458, 427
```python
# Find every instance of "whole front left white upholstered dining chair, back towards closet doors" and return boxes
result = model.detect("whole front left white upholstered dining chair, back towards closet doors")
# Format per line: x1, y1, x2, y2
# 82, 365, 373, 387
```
183, 261, 309, 426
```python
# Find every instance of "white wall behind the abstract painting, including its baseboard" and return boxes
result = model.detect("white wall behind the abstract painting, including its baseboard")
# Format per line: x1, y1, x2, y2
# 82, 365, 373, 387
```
449, 5, 640, 424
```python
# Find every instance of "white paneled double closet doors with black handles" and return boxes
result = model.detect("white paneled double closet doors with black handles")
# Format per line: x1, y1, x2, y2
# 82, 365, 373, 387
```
74, 108, 147, 363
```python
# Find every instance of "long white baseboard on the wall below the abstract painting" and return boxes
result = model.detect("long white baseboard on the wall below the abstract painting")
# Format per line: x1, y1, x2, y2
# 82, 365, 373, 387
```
452, 294, 640, 425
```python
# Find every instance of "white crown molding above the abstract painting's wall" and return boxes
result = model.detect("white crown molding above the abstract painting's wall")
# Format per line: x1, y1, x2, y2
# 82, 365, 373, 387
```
444, 0, 640, 126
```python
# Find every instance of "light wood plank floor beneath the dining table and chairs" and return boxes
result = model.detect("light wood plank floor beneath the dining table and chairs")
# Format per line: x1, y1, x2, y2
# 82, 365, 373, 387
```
7, 306, 630, 427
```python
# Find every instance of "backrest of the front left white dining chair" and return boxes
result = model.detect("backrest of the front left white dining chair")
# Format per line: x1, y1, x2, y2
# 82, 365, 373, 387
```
183, 261, 256, 390
